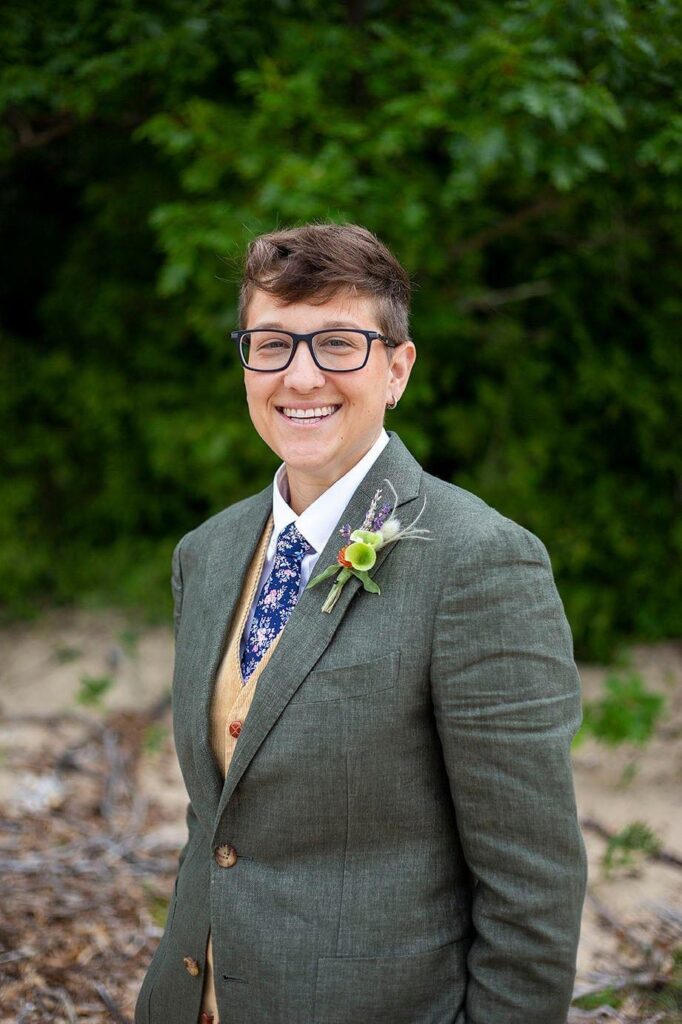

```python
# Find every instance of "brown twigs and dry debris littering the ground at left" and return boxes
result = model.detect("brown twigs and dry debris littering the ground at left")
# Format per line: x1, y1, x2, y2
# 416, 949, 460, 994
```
0, 700, 179, 1024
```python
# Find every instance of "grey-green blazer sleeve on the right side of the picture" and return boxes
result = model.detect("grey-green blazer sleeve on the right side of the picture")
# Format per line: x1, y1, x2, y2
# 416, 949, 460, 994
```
431, 516, 587, 1024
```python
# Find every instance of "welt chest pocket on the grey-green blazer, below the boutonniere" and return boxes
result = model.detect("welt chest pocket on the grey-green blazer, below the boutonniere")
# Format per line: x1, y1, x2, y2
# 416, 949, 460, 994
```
290, 650, 400, 705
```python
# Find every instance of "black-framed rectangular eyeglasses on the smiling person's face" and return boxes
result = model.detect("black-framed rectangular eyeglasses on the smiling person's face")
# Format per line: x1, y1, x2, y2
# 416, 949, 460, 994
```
230, 327, 400, 374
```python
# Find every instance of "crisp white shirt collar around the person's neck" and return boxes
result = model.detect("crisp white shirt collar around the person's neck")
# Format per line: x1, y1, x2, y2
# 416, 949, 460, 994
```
271, 427, 390, 554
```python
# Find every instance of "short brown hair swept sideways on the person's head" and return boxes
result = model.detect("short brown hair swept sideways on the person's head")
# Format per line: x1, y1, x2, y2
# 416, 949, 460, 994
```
239, 224, 411, 341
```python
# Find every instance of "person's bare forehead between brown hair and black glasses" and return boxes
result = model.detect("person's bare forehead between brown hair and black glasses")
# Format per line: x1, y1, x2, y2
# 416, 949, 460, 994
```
246, 289, 378, 332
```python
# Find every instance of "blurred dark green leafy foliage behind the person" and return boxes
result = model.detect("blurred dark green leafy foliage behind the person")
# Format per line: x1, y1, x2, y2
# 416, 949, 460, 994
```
0, 0, 682, 656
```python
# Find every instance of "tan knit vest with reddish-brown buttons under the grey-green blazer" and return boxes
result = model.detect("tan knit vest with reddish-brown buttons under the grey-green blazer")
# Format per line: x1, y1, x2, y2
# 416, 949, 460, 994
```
197, 515, 282, 1024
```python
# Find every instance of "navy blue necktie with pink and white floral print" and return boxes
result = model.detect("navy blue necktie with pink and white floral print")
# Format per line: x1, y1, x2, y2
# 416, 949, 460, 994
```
242, 522, 315, 684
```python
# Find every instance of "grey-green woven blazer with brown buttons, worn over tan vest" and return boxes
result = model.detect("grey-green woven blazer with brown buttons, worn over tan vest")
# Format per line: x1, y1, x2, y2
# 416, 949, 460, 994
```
135, 431, 587, 1024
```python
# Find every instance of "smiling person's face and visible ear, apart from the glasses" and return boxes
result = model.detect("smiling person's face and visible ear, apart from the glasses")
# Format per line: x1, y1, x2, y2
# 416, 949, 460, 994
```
244, 291, 417, 500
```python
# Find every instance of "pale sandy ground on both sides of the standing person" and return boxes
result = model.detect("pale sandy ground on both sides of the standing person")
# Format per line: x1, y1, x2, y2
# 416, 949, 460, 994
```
0, 611, 682, 981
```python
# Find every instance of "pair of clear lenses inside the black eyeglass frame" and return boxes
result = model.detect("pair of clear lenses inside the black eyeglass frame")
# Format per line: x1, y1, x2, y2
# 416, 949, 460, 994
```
241, 330, 370, 370
